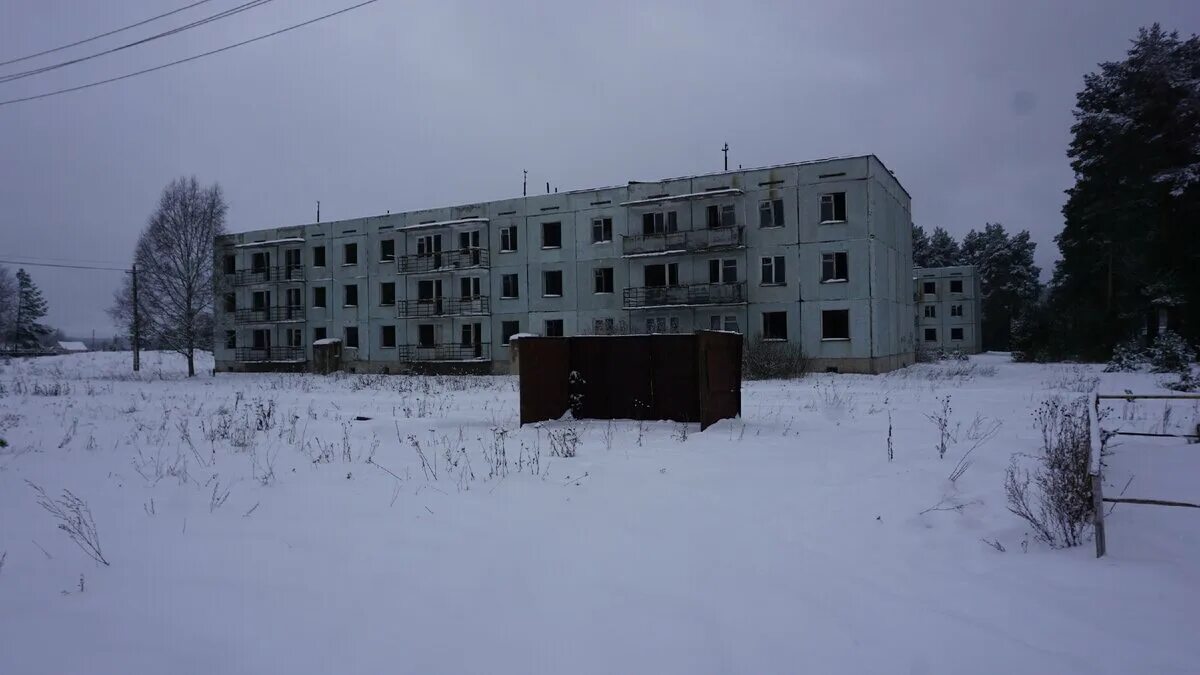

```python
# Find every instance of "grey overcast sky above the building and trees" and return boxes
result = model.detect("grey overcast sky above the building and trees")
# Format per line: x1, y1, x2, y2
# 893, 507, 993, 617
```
0, 0, 1200, 336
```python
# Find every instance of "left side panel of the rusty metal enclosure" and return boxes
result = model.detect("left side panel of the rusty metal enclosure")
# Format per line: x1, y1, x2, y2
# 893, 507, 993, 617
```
517, 338, 571, 424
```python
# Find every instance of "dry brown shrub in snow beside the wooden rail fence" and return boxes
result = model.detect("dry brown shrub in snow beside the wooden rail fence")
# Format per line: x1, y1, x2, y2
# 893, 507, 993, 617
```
1004, 398, 1092, 549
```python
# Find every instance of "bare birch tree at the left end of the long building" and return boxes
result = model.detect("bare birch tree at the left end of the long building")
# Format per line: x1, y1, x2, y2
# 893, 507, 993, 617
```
109, 177, 228, 377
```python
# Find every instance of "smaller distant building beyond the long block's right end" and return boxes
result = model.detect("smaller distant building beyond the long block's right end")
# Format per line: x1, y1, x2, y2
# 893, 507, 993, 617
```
913, 265, 983, 354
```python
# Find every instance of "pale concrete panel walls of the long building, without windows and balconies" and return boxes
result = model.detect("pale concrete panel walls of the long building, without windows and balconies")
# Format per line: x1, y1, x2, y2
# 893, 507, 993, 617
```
208, 156, 914, 372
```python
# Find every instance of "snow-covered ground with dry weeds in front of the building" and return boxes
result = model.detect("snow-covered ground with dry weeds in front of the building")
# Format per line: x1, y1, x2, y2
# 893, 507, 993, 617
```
0, 353, 1200, 675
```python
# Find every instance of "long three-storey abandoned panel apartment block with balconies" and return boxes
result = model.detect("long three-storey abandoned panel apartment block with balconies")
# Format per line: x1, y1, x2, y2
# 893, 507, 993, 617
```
214, 155, 916, 372
